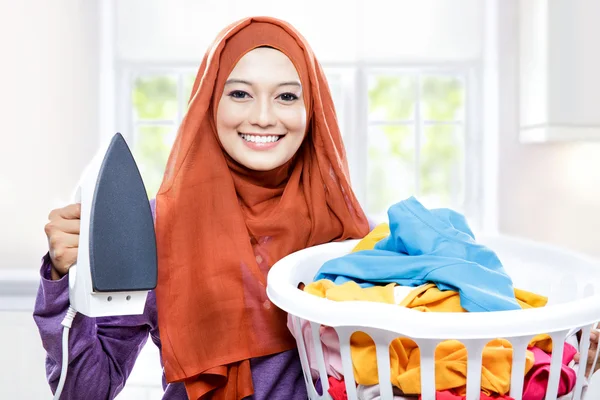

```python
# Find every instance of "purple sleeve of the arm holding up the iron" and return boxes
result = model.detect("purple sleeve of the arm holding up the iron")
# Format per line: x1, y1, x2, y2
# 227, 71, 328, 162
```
33, 200, 160, 399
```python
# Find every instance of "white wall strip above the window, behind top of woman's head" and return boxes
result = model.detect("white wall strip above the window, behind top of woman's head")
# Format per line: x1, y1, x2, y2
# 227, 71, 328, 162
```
117, 0, 484, 63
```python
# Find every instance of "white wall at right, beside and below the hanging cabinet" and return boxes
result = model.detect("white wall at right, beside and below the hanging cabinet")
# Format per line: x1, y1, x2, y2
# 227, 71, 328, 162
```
498, 0, 600, 256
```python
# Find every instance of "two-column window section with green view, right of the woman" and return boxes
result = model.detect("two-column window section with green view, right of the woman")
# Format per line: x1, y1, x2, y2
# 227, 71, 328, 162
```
366, 69, 466, 222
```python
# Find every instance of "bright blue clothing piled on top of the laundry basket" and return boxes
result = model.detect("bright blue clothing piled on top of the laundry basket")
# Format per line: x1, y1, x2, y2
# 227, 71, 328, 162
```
314, 197, 520, 311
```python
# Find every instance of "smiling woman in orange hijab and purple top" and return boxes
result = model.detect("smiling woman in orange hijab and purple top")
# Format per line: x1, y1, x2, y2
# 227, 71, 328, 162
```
34, 17, 369, 400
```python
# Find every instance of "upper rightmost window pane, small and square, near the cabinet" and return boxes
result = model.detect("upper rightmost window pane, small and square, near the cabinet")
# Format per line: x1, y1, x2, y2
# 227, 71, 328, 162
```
421, 76, 465, 121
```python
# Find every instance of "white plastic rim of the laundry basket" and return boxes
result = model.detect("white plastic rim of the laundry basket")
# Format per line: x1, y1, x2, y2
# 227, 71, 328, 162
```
267, 235, 600, 340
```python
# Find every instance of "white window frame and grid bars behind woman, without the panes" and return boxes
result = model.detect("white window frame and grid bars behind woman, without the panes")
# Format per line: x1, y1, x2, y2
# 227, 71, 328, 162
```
117, 62, 483, 229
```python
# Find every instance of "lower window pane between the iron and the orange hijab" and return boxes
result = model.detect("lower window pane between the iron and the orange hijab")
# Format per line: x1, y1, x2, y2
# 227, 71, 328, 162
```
133, 125, 177, 198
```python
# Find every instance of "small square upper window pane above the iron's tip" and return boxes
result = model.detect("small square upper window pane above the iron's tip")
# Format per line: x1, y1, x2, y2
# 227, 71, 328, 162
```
132, 75, 177, 120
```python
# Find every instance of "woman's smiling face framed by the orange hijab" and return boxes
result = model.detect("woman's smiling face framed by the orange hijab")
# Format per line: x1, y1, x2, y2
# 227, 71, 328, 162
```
216, 48, 306, 171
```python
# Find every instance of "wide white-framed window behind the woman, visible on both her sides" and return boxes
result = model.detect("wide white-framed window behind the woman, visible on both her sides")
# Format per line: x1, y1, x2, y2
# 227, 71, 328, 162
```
127, 65, 479, 225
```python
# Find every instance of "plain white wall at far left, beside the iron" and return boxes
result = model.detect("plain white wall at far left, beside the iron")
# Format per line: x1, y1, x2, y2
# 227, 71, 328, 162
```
0, 0, 98, 269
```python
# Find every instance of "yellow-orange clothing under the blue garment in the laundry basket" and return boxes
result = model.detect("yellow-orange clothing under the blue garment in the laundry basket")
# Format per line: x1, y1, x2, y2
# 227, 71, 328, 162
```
304, 224, 552, 394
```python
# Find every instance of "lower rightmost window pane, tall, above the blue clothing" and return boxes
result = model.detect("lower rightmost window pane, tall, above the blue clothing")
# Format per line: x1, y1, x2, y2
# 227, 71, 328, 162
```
420, 125, 465, 208
